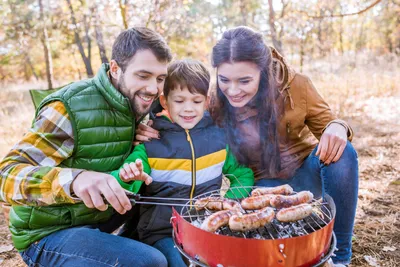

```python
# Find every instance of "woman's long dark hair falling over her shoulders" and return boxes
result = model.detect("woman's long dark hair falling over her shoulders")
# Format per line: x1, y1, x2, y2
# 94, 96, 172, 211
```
211, 26, 280, 177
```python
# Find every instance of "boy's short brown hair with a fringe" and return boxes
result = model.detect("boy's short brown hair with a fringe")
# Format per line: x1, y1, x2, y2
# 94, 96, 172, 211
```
164, 59, 210, 97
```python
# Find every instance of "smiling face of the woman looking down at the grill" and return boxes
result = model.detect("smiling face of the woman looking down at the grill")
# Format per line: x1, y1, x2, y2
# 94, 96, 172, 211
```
217, 61, 261, 108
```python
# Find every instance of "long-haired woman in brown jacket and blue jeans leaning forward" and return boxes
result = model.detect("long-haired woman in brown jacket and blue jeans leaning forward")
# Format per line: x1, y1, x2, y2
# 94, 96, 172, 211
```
211, 27, 358, 266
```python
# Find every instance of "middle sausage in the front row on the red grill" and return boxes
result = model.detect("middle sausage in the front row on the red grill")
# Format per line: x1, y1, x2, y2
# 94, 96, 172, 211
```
229, 207, 275, 232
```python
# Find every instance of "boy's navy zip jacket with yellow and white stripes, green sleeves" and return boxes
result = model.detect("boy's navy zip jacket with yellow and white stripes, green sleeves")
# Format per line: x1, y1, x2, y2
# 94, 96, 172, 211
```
112, 112, 254, 245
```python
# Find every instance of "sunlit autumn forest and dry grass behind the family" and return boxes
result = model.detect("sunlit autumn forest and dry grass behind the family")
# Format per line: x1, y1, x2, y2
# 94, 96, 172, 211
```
0, 0, 400, 266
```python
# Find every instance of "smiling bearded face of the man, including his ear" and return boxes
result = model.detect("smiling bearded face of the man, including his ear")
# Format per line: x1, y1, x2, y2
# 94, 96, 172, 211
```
111, 50, 168, 116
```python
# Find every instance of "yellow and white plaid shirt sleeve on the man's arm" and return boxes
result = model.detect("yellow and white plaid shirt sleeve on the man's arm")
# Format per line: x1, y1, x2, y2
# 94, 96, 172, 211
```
0, 101, 83, 206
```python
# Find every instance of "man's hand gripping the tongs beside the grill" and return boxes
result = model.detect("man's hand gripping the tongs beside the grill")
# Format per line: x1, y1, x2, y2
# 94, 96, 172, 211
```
71, 171, 132, 214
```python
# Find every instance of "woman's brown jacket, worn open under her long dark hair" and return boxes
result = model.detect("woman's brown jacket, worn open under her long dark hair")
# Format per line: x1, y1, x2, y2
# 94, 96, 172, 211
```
236, 48, 353, 180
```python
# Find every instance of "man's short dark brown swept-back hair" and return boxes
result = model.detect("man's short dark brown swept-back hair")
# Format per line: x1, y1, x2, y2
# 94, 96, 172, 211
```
111, 27, 172, 72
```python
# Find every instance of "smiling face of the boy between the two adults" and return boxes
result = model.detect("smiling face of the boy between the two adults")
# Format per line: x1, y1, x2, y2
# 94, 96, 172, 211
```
166, 87, 207, 130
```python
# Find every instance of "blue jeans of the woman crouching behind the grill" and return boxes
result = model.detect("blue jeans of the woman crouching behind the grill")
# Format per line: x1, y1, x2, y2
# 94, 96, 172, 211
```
256, 142, 358, 264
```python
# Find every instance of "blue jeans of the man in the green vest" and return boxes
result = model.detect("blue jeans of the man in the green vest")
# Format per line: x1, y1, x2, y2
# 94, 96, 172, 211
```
21, 227, 167, 267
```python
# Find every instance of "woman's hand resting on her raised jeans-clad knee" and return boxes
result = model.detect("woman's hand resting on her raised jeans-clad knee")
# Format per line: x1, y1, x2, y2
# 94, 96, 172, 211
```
315, 123, 347, 165
